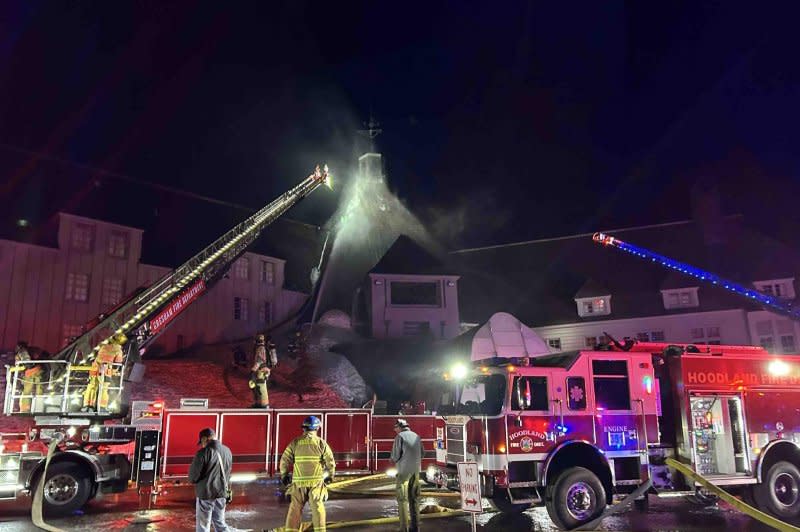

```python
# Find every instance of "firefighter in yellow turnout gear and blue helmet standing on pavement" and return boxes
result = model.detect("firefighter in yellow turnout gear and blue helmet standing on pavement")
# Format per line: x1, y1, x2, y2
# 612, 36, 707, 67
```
280, 416, 336, 532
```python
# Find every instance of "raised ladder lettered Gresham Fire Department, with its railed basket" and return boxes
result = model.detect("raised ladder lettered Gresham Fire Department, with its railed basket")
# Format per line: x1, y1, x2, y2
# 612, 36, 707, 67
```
4, 165, 330, 424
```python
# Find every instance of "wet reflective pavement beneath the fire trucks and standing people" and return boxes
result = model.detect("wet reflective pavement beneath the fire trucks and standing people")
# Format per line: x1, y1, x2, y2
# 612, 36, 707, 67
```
0, 480, 788, 532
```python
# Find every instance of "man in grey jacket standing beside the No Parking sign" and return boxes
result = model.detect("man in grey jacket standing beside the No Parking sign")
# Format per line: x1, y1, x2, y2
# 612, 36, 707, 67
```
390, 419, 422, 532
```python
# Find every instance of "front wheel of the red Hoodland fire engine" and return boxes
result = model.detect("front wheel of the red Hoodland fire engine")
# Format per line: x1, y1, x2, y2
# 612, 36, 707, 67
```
546, 467, 606, 530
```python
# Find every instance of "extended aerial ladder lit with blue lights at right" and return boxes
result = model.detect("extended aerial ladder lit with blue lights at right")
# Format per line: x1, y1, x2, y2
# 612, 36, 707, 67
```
592, 233, 800, 321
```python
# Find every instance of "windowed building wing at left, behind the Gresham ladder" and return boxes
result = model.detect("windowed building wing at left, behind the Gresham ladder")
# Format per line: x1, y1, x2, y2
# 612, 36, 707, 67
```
0, 213, 307, 352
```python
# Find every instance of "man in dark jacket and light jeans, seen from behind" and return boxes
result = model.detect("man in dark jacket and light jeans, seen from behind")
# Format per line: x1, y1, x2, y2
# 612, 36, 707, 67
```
189, 428, 233, 532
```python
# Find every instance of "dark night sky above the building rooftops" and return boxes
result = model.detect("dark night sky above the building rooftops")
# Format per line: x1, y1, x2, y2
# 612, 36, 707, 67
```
0, 0, 800, 251
